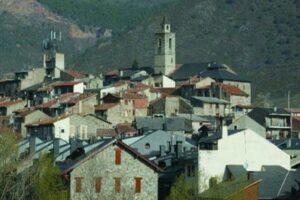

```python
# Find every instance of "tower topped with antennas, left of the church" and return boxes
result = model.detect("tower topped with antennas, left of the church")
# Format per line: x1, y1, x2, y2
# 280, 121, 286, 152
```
43, 31, 65, 79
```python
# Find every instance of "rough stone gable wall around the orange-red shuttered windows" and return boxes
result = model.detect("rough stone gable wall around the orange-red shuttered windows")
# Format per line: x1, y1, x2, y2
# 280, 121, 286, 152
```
70, 145, 158, 200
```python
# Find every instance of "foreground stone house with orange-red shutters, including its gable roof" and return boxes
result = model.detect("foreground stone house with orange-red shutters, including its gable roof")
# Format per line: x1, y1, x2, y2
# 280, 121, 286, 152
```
64, 140, 162, 200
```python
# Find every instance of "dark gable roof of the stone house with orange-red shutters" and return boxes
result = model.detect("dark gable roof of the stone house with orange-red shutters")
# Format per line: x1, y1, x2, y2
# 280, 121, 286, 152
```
63, 139, 163, 174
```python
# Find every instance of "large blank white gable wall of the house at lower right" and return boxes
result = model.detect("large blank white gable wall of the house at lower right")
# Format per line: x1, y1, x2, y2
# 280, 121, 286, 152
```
198, 129, 290, 190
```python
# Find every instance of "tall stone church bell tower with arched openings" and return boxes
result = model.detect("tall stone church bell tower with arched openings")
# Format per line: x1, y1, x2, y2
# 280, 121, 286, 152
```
154, 17, 176, 75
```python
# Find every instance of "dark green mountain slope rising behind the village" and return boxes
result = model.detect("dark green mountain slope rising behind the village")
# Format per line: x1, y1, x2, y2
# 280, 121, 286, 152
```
0, 0, 300, 105
